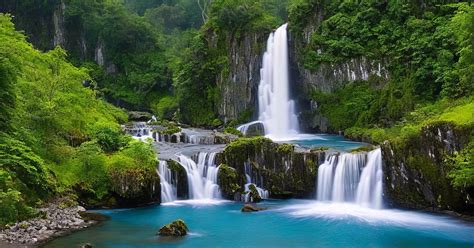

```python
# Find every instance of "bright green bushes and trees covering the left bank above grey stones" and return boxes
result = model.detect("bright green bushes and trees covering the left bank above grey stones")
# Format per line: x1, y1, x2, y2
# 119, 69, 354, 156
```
0, 14, 156, 225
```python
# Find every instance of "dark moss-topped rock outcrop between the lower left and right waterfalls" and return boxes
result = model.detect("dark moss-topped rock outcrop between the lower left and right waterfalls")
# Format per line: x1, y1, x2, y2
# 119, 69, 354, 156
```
218, 137, 325, 199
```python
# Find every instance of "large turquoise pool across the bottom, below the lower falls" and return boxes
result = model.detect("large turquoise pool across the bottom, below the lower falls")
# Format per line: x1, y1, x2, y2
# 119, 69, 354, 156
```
46, 200, 474, 248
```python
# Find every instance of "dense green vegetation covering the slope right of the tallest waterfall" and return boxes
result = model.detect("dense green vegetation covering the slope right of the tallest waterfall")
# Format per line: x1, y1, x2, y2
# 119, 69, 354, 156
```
289, 0, 474, 187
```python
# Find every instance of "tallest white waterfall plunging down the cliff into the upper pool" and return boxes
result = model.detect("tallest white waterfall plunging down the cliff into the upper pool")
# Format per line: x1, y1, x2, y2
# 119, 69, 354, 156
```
238, 24, 299, 140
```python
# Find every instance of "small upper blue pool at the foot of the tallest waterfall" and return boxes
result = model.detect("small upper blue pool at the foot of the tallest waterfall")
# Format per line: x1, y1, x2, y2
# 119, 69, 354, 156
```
284, 134, 369, 151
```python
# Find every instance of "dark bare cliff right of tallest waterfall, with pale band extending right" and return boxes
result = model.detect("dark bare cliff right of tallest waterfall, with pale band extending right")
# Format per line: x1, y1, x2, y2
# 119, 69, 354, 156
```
289, 4, 390, 132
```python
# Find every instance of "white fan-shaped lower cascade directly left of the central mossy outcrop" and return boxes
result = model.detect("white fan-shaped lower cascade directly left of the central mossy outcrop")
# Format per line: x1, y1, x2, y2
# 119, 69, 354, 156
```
178, 152, 221, 199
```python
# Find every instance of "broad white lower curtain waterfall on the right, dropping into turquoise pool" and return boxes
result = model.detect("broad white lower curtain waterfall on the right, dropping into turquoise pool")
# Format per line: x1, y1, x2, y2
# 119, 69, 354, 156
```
317, 148, 383, 208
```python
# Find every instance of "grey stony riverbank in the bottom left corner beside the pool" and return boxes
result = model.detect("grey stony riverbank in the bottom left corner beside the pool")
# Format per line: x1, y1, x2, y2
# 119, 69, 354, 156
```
0, 203, 103, 247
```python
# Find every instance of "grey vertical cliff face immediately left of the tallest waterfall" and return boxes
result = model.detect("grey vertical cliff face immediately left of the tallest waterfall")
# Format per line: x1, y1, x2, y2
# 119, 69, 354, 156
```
216, 33, 268, 122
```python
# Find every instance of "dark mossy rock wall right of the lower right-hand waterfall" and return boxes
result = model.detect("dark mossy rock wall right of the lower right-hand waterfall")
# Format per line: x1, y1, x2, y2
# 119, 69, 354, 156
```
382, 123, 474, 214
